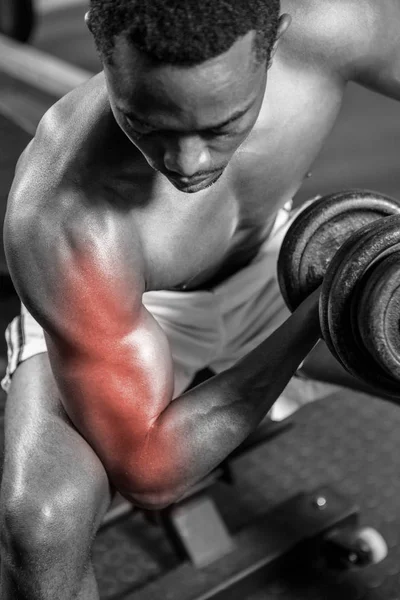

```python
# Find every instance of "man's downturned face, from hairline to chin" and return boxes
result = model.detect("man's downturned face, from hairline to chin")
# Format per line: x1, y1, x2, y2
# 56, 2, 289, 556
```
104, 32, 267, 193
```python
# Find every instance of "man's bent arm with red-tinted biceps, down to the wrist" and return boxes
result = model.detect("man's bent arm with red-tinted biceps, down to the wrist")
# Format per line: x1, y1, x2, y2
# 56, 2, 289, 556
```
3, 196, 319, 508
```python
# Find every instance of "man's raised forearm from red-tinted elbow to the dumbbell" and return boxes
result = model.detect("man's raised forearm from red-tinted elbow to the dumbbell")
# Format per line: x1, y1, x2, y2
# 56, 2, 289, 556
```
121, 295, 320, 507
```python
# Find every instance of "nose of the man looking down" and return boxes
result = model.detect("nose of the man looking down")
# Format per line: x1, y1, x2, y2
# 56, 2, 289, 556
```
164, 135, 210, 177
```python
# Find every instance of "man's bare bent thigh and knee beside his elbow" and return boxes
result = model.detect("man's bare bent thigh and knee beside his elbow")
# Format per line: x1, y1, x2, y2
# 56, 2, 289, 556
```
0, 355, 113, 551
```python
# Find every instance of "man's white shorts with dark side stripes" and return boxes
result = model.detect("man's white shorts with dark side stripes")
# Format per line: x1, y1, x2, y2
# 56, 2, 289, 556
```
1, 202, 340, 420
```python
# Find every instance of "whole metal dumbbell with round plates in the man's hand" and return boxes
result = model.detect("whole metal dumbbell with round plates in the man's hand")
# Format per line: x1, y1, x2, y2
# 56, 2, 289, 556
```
278, 189, 400, 398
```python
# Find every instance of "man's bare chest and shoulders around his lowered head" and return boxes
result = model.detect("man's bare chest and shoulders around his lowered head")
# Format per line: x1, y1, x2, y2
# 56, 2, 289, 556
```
10, 2, 350, 291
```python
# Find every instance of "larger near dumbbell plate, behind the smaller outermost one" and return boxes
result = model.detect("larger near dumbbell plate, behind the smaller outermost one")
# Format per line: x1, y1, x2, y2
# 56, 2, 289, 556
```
319, 215, 400, 397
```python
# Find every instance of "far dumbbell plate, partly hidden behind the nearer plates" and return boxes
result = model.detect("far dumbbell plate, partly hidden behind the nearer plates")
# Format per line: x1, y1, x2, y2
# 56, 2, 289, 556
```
278, 189, 400, 311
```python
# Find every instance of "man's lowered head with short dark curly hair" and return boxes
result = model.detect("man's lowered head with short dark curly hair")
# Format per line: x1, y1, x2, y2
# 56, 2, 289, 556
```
86, 0, 290, 192
